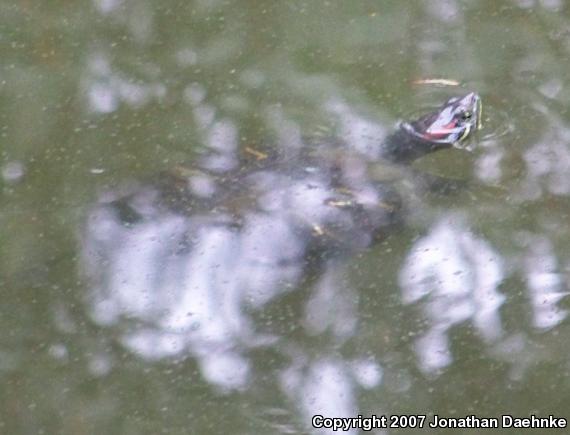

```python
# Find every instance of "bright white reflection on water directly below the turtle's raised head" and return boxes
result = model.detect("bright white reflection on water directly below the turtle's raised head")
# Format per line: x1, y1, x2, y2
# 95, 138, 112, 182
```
400, 216, 505, 372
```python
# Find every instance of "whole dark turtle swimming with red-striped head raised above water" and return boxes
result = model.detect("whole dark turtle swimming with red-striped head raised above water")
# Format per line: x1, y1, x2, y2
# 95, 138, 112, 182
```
140, 92, 481, 258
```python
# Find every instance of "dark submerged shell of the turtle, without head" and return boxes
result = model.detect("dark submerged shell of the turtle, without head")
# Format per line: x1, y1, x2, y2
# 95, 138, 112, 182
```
113, 143, 402, 261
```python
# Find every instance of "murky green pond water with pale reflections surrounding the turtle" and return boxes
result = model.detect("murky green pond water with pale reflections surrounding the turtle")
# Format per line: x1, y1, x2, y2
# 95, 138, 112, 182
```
0, 0, 570, 434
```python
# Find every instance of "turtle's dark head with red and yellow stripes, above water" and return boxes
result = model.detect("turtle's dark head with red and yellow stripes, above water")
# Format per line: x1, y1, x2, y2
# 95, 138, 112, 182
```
402, 92, 481, 151
